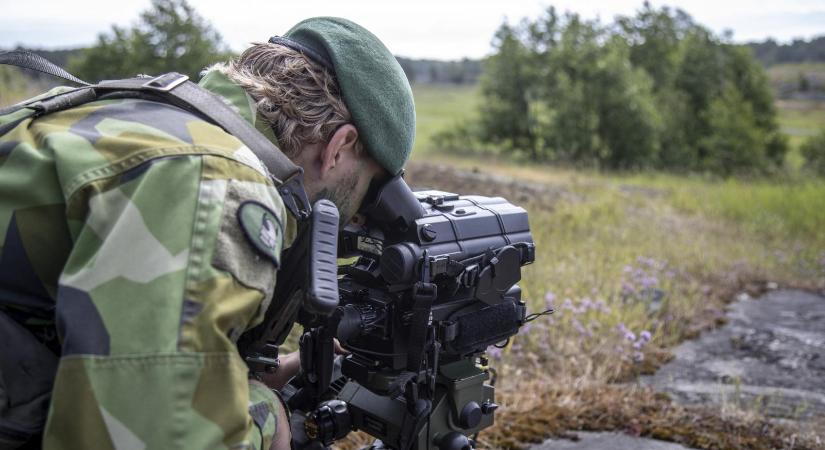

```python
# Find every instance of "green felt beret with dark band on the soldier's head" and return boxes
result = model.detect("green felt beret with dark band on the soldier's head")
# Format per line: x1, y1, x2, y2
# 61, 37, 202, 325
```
284, 17, 415, 175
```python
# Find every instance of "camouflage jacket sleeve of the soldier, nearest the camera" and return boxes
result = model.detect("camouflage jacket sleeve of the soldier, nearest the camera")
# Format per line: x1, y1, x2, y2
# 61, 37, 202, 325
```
44, 154, 285, 449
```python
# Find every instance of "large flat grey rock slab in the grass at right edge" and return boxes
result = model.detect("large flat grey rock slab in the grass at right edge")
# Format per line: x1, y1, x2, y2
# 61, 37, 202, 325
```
643, 291, 825, 420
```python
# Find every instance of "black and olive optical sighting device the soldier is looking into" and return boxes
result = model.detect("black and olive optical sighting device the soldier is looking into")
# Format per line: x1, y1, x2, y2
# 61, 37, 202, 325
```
282, 176, 548, 450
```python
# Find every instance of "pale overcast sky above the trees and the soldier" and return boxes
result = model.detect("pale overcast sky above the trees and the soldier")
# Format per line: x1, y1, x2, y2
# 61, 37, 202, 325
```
0, 0, 825, 59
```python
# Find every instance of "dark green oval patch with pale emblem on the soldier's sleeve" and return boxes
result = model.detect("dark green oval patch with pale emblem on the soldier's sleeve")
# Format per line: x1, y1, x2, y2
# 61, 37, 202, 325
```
238, 201, 284, 267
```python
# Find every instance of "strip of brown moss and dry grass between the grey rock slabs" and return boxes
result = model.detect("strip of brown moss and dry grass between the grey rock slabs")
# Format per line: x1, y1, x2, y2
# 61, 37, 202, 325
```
479, 369, 825, 450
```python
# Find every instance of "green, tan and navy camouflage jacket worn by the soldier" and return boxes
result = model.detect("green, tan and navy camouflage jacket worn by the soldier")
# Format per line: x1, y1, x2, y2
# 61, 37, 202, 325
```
0, 71, 295, 449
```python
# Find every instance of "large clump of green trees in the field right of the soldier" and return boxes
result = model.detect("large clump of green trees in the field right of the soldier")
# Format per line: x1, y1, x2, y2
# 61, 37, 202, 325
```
437, 3, 788, 175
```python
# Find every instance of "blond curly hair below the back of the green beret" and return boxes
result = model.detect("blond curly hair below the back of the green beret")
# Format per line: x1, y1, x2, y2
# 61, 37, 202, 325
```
215, 43, 363, 157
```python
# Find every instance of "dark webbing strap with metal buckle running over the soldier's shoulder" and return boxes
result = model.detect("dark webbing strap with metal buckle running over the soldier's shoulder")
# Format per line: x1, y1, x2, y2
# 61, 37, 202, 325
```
0, 50, 312, 220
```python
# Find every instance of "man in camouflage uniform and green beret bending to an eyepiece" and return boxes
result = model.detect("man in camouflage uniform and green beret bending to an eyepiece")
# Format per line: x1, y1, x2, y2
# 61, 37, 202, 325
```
0, 18, 415, 450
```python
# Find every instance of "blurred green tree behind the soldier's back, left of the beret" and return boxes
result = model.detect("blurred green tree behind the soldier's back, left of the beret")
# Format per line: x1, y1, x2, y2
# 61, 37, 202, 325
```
69, 0, 229, 81
